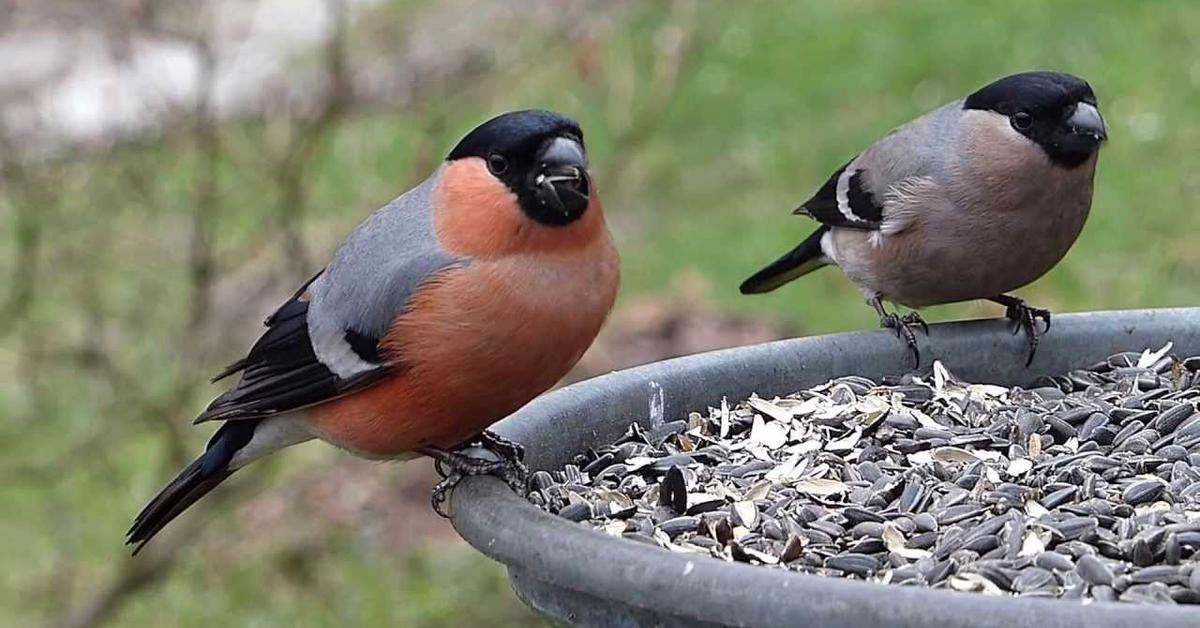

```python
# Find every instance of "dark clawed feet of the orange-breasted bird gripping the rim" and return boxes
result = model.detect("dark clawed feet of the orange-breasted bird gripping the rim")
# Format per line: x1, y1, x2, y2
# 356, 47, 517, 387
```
420, 431, 529, 518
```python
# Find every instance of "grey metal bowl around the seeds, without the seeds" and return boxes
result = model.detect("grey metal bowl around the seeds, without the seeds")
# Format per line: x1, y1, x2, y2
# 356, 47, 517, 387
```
451, 309, 1200, 628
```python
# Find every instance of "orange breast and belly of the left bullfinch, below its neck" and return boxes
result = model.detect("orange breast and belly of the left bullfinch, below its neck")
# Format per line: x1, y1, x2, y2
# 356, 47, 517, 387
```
310, 169, 618, 457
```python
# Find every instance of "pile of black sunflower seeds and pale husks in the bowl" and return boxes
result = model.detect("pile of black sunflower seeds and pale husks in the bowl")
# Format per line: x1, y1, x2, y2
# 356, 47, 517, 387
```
529, 346, 1200, 604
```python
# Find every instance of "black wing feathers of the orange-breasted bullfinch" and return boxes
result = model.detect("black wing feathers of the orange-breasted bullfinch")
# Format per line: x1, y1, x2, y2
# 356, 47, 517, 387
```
196, 274, 391, 423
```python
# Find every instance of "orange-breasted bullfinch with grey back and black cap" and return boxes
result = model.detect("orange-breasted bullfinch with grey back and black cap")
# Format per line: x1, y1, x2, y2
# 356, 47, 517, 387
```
127, 110, 618, 554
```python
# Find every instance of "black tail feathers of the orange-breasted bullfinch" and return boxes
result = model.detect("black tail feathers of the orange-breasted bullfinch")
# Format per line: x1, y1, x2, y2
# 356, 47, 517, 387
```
125, 419, 259, 556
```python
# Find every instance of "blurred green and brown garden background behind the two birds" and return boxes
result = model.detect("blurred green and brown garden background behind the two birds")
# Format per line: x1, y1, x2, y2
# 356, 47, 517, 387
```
0, 0, 1200, 627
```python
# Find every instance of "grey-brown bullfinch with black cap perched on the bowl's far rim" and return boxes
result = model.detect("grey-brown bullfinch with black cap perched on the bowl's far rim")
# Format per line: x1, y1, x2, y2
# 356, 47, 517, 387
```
742, 72, 1108, 365
